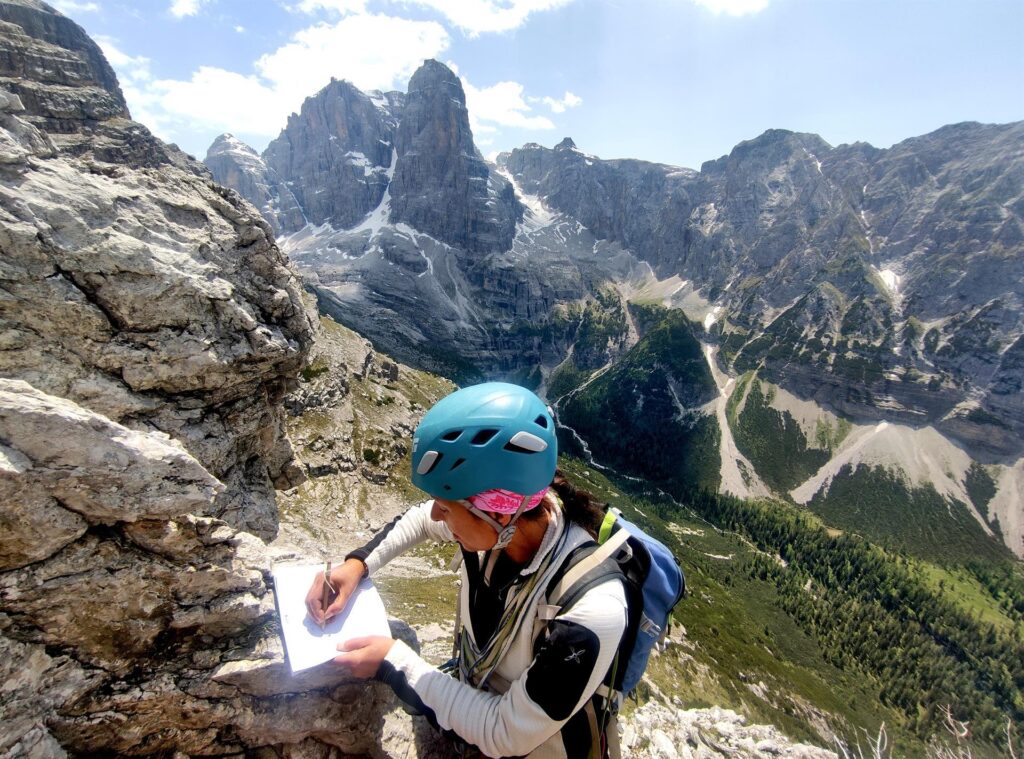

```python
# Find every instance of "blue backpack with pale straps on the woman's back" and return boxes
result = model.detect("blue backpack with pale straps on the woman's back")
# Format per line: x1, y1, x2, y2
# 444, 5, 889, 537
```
547, 508, 686, 700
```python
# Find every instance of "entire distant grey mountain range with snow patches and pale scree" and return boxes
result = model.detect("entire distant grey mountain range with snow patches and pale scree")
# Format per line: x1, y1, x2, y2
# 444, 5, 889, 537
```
206, 61, 1024, 555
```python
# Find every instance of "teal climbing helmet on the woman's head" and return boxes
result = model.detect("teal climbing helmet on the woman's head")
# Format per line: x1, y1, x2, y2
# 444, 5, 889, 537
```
413, 382, 558, 501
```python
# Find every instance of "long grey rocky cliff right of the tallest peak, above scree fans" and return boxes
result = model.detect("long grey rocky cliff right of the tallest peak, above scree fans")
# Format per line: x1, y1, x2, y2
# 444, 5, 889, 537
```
504, 124, 1024, 460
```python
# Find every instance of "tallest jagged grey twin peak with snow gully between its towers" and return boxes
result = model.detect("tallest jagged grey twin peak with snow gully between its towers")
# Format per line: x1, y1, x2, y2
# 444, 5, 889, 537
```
209, 59, 519, 251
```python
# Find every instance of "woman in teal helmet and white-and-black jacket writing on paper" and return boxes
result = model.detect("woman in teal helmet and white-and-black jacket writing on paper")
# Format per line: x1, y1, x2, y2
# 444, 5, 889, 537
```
306, 382, 627, 759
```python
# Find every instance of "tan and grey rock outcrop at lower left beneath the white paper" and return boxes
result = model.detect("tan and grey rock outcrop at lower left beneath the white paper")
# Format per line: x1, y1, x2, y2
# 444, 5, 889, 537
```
0, 380, 443, 757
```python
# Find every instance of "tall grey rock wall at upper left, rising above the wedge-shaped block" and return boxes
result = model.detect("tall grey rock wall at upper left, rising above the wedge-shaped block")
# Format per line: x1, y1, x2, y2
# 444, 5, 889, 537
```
0, 2, 312, 537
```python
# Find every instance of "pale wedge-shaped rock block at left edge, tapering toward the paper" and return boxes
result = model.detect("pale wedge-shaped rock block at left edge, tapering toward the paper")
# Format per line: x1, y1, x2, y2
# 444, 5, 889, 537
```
0, 379, 223, 570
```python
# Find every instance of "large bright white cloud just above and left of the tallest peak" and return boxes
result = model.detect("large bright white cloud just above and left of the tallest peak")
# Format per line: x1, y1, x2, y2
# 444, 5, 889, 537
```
100, 15, 450, 152
